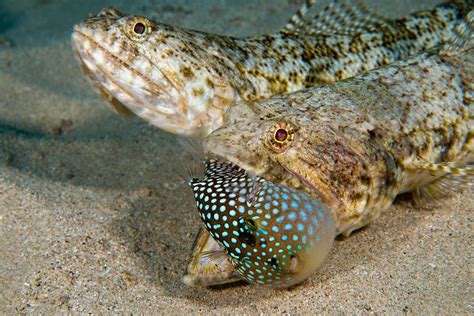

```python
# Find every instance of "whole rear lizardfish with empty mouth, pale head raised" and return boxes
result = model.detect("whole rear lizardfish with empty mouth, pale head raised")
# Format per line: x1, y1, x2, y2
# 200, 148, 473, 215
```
72, 0, 472, 136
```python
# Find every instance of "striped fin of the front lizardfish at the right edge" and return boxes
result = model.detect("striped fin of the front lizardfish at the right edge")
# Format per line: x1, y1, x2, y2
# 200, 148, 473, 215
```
411, 162, 474, 206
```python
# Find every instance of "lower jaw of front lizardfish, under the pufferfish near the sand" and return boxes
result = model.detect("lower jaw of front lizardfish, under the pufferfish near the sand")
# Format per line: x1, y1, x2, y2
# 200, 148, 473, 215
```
183, 229, 242, 286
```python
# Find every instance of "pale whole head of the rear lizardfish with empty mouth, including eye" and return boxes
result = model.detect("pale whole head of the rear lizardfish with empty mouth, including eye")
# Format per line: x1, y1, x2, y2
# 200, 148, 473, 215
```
72, 8, 236, 135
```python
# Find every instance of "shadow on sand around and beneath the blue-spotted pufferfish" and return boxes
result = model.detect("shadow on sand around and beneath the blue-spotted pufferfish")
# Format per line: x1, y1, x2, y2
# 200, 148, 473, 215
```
106, 159, 427, 307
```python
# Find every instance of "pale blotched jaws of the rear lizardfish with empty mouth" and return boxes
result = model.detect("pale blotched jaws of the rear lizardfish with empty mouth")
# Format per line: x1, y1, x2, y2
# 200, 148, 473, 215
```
71, 24, 195, 134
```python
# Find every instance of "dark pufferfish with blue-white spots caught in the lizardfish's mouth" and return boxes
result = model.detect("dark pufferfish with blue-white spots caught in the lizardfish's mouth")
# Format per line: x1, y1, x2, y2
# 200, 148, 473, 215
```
189, 160, 336, 287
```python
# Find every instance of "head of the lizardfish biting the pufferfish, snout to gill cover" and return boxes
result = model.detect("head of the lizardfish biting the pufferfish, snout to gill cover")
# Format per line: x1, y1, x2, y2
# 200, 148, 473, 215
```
203, 89, 388, 235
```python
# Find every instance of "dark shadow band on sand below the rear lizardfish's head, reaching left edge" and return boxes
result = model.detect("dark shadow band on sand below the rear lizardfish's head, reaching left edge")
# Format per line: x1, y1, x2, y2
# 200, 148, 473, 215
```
0, 121, 179, 190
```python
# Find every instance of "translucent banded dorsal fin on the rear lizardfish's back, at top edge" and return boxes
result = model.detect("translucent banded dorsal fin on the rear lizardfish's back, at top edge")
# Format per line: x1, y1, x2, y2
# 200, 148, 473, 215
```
282, 0, 391, 35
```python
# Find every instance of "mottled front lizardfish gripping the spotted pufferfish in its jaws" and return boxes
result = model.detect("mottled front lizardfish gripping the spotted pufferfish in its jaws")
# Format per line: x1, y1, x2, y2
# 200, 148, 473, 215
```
183, 12, 474, 285
